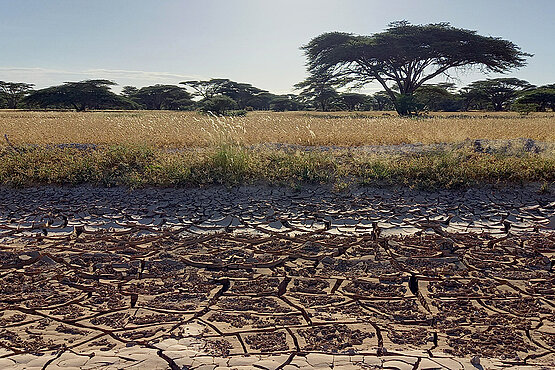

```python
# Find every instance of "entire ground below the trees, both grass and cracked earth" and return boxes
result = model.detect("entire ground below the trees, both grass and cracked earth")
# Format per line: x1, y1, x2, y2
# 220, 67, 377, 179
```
0, 110, 555, 370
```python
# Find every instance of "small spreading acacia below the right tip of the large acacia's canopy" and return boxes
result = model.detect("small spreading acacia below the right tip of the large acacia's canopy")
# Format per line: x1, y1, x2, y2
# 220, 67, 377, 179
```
464, 78, 535, 111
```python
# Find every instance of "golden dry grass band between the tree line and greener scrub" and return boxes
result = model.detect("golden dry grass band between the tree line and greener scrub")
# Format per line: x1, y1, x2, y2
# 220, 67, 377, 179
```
0, 111, 555, 147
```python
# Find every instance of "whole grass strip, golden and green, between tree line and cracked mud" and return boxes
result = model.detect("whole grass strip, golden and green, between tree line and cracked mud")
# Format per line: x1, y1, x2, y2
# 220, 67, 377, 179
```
0, 111, 555, 189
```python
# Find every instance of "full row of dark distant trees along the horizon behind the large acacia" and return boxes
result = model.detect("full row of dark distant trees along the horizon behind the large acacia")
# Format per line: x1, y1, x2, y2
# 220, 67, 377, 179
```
0, 77, 555, 114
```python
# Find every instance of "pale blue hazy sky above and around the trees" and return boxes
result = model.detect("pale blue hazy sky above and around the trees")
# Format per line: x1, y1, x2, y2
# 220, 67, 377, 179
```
0, 0, 555, 93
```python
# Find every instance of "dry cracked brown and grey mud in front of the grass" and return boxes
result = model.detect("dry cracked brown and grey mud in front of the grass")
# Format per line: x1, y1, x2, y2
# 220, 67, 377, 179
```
0, 187, 555, 369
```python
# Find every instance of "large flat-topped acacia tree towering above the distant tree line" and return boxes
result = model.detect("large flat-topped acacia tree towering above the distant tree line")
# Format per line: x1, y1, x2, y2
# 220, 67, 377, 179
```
302, 21, 531, 115
